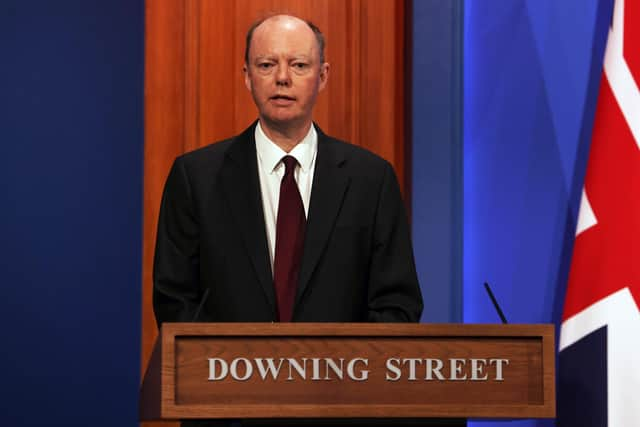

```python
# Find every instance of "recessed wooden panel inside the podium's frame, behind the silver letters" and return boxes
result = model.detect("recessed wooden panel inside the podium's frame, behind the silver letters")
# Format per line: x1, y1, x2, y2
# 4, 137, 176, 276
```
175, 337, 543, 408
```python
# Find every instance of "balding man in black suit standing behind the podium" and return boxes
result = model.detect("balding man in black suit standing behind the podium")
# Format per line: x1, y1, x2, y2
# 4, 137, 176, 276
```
153, 15, 422, 324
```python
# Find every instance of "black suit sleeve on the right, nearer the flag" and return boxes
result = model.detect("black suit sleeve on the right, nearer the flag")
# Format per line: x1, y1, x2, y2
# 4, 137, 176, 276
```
368, 162, 423, 322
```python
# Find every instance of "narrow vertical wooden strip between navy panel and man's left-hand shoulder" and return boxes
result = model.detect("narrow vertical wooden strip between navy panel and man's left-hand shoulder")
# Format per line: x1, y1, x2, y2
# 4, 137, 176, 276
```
141, 1, 186, 427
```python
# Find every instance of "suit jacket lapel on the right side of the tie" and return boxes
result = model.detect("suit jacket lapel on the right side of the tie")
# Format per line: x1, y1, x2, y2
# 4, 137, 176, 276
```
294, 126, 349, 313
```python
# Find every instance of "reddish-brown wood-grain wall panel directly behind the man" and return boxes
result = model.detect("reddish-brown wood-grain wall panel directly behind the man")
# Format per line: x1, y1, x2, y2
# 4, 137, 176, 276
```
141, 0, 408, 427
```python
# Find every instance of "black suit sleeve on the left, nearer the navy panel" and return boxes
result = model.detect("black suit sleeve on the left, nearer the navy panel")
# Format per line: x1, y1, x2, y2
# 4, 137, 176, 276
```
153, 158, 200, 325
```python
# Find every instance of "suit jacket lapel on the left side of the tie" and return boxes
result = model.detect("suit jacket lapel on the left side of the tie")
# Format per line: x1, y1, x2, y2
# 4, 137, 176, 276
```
221, 123, 276, 313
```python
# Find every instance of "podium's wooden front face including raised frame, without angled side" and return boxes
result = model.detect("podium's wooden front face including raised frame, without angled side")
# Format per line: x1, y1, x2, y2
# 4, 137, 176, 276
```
140, 324, 555, 418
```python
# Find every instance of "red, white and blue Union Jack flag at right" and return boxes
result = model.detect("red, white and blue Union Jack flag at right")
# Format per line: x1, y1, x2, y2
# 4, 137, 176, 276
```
558, 0, 640, 427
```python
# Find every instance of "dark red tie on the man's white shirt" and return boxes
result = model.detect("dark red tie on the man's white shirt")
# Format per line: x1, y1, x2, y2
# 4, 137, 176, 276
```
273, 156, 307, 322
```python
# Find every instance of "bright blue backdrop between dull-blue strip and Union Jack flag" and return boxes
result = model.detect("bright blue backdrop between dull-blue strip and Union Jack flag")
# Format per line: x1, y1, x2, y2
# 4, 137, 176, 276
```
463, 0, 612, 426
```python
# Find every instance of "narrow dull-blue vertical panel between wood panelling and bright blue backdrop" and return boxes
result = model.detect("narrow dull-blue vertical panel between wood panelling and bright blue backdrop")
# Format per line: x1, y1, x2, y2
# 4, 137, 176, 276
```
411, 0, 463, 322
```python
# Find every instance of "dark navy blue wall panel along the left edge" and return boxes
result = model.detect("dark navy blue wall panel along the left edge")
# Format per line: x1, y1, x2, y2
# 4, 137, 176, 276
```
0, 0, 144, 427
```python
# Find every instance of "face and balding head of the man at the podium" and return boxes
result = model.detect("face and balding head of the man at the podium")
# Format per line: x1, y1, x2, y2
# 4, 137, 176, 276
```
244, 16, 329, 126
